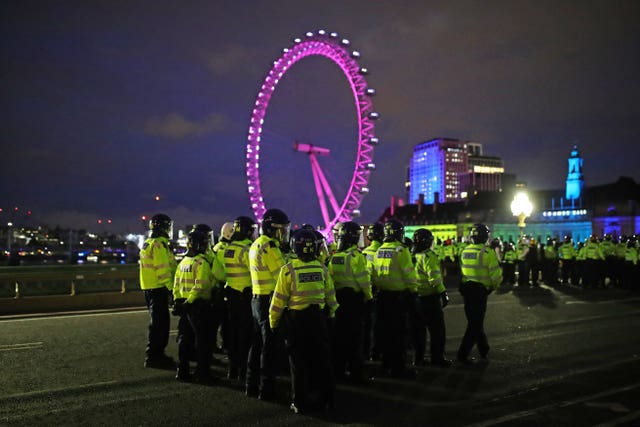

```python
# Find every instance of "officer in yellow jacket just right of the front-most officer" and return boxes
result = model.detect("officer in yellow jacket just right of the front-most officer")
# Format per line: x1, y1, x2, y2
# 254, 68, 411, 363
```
329, 221, 373, 383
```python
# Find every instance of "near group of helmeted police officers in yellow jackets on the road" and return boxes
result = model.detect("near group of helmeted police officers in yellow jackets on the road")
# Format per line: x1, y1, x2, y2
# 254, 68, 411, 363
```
140, 213, 502, 412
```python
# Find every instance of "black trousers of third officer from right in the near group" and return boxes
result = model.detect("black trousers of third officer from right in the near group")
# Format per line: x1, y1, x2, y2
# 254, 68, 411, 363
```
376, 291, 409, 374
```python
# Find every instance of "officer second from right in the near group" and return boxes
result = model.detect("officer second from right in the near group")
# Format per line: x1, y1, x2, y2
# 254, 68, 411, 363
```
413, 228, 451, 367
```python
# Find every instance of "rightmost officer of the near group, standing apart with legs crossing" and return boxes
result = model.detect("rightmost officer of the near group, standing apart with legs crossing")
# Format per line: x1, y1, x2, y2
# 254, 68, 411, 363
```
458, 224, 502, 365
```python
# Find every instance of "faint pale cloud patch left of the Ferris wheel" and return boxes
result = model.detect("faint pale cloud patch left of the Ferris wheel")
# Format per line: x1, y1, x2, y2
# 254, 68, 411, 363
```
144, 113, 230, 139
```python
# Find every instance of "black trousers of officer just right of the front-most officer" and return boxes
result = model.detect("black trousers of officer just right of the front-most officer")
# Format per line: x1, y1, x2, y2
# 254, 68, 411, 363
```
332, 288, 365, 381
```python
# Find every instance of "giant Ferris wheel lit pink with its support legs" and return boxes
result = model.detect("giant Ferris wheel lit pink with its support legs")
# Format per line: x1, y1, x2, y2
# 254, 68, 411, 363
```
246, 30, 379, 235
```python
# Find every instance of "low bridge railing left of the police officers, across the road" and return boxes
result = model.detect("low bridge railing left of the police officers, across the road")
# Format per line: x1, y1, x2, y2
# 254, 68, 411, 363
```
0, 264, 140, 299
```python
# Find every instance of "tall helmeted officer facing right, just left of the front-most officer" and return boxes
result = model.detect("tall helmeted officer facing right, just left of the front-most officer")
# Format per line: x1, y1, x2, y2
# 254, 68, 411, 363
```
245, 209, 290, 400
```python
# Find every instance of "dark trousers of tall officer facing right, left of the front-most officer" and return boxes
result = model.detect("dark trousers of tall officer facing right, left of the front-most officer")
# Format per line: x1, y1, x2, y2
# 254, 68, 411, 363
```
246, 293, 277, 397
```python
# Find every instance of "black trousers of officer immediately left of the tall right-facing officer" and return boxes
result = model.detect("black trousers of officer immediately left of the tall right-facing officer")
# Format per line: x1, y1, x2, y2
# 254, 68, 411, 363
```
224, 286, 253, 379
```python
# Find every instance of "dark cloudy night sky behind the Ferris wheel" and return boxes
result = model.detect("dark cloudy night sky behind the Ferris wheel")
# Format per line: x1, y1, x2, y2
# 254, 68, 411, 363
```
0, 0, 640, 232
